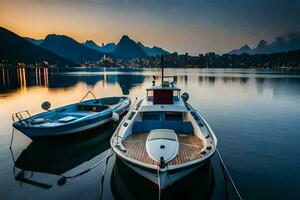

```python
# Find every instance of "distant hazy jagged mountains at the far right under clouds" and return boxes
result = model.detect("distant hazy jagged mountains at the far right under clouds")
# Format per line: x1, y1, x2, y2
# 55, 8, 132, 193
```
229, 36, 300, 55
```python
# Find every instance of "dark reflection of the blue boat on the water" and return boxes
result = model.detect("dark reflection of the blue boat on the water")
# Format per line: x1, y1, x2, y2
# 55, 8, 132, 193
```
12, 124, 117, 189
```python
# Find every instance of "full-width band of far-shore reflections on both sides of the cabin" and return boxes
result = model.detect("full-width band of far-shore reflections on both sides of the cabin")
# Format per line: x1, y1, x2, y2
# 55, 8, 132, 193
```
0, 68, 300, 99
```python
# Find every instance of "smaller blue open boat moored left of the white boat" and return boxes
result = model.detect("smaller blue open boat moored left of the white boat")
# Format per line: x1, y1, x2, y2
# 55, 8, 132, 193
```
12, 92, 131, 139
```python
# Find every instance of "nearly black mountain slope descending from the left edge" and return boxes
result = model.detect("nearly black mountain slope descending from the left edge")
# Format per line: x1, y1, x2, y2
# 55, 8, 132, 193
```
0, 27, 78, 66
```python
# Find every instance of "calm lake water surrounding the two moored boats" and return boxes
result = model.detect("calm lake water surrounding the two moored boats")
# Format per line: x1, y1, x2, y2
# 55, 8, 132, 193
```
0, 68, 300, 199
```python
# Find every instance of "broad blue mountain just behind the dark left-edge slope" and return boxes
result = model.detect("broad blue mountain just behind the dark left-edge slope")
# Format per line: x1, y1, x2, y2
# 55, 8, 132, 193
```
40, 34, 104, 63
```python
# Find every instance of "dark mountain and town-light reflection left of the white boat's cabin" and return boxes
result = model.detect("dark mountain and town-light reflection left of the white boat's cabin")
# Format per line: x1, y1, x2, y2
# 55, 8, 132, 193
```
0, 68, 146, 95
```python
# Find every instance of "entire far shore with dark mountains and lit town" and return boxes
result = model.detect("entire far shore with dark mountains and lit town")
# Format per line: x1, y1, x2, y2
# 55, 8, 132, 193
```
0, 27, 300, 70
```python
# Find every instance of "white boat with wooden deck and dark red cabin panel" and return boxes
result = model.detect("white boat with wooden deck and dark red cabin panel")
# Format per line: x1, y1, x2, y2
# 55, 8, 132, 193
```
110, 76, 217, 189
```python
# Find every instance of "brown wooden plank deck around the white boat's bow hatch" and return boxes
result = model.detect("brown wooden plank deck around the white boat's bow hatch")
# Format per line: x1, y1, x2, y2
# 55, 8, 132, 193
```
123, 134, 204, 165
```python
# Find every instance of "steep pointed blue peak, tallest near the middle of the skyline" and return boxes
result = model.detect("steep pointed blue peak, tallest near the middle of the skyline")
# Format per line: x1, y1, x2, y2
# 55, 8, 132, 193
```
112, 35, 147, 60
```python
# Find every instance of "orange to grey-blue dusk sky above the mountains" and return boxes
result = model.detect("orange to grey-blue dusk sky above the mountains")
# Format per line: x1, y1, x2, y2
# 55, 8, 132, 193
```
0, 0, 300, 55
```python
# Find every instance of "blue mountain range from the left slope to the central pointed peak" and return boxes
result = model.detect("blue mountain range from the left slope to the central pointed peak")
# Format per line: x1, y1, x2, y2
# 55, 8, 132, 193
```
25, 34, 169, 63
